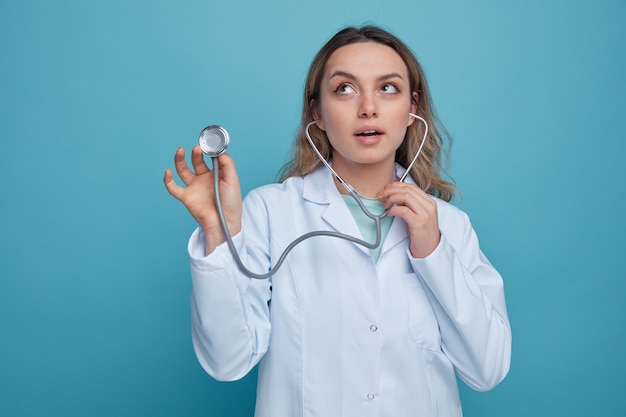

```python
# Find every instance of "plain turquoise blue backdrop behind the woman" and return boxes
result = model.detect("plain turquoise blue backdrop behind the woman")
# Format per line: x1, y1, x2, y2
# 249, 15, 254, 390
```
0, 0, 626, 417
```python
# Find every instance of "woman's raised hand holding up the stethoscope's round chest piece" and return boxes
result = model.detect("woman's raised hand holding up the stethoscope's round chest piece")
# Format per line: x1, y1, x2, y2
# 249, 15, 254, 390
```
163, 145, 242, 254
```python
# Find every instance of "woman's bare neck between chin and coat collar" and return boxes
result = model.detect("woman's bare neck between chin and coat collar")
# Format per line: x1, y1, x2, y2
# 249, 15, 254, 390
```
333, 160, 395, 198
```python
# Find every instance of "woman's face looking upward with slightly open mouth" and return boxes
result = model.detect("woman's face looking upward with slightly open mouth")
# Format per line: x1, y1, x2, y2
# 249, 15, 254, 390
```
314, 42, 417, 176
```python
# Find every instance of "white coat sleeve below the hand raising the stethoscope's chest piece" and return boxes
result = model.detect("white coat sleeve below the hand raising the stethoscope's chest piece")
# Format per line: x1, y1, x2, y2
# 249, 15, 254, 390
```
188, 228, 271, 380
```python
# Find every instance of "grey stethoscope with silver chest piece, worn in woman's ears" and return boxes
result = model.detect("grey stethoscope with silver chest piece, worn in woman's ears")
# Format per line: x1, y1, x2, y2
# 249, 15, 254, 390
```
198, 113, 428, 279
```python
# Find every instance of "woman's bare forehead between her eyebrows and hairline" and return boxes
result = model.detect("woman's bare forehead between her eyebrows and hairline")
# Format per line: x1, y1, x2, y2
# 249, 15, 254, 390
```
324, 42, 408, 77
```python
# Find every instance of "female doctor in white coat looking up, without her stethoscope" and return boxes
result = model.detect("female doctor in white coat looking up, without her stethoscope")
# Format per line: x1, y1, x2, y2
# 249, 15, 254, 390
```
164, 26, 511, 417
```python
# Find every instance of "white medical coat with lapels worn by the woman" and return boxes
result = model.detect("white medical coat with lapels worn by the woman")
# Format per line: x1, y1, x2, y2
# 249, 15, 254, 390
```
189, 167, 511, 417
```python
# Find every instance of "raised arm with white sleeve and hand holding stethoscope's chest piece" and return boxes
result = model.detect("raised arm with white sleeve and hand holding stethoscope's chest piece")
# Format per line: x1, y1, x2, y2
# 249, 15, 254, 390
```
163, 146, 270, 380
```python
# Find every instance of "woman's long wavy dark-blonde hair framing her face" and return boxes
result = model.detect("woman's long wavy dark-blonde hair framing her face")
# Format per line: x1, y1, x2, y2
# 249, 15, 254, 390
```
279, 26, 456, 201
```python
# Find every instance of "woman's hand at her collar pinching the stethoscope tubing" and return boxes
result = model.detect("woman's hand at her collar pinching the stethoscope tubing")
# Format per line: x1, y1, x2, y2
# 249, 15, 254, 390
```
377, 182, 441, 258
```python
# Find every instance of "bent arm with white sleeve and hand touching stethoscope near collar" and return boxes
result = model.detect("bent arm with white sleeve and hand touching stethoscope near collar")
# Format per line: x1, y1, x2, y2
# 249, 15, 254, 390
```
379, 182, 511, 390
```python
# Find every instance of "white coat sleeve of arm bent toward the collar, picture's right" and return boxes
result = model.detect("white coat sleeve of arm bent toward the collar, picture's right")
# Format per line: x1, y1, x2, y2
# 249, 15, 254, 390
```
411, 207, 511, 391
